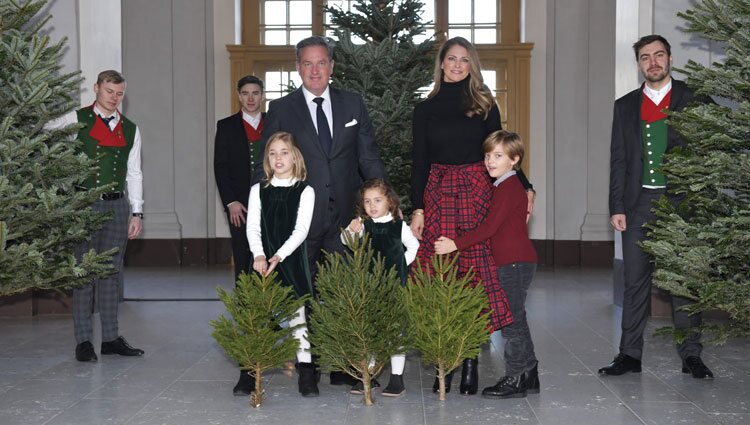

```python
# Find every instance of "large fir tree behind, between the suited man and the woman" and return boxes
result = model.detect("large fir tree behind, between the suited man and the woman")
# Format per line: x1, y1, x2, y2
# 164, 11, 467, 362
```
326, 0, 434, 212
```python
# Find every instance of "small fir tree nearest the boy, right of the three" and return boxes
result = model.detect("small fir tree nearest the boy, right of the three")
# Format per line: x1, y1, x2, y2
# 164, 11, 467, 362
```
403, 254, 491, 401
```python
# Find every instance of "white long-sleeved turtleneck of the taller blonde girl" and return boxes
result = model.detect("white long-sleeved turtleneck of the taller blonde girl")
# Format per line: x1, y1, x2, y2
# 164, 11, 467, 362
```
247, 177, 315, 261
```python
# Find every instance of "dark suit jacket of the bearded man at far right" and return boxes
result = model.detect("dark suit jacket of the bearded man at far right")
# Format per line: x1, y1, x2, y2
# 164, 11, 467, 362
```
609, 78, 695, 216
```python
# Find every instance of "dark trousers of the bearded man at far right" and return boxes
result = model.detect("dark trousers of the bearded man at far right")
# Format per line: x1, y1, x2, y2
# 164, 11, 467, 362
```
620, 188, 703, 360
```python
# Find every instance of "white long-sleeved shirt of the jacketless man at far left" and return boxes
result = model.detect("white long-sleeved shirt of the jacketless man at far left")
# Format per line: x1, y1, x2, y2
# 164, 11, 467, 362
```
44, 105, 143, 213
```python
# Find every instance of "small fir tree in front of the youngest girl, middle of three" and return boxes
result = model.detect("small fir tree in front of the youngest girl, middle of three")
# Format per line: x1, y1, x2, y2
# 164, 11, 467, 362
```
310, 233, 406, 406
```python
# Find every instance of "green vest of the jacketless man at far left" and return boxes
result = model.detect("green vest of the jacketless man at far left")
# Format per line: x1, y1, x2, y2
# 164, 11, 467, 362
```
77, 107, 136, 192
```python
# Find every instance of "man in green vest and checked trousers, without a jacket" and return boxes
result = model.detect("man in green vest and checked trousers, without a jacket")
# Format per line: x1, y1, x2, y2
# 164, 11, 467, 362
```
53, 70, 143, 362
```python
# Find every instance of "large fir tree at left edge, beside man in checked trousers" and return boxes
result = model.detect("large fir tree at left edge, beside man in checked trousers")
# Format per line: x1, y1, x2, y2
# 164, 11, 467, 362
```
0, 0, 111, 296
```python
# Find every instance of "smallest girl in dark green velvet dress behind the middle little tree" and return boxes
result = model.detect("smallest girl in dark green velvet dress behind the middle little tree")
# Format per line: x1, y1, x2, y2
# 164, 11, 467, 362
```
341, 179, 419, 397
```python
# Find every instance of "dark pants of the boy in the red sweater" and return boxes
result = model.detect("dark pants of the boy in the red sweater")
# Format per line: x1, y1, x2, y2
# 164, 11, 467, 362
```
497, 263, 536, 376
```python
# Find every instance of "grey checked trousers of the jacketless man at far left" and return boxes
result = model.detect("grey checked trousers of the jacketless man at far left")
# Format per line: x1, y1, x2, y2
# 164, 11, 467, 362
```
73, 197, 130, 344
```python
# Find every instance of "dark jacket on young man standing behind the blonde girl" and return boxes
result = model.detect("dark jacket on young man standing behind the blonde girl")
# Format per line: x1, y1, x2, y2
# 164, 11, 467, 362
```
214, 111, 265, 210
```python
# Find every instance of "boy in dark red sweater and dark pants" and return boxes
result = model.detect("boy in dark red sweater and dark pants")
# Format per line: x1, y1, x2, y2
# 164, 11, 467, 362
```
435, 130, 539, 398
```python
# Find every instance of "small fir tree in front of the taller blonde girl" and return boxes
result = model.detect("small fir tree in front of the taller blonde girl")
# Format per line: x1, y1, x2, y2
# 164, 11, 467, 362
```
210, 272, 309, 407
